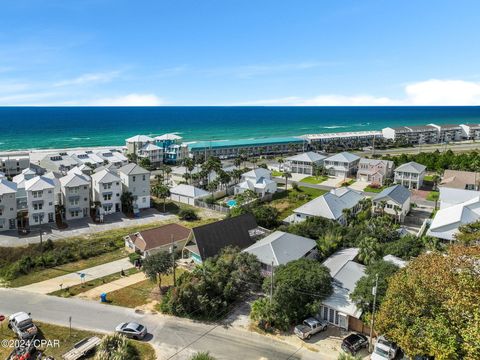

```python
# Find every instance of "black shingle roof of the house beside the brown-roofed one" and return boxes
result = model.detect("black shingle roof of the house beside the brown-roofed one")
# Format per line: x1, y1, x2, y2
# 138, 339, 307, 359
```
192, 214, 258, 260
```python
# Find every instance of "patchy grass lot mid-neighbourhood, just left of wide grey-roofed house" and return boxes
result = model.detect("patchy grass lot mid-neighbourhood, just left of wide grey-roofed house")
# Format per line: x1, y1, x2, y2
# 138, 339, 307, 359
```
270, 186, 327, 220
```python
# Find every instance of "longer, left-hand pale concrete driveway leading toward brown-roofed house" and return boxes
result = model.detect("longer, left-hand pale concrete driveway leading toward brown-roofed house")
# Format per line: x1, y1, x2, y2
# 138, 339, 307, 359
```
18, 258, 133, 294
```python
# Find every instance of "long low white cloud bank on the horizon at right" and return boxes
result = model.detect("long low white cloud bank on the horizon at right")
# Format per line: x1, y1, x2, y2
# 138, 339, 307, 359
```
236, 79, 480, 106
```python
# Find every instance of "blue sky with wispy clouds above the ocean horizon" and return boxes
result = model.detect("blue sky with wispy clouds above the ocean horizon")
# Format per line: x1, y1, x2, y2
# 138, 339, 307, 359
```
0, 0, 480, 105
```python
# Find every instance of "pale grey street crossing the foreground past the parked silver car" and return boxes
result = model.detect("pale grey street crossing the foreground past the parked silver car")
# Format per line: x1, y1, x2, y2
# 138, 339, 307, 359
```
0, 288, 318, 360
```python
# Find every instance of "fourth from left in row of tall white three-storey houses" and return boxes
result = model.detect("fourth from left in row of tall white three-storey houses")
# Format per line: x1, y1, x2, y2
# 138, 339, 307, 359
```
92, 169, 122, 215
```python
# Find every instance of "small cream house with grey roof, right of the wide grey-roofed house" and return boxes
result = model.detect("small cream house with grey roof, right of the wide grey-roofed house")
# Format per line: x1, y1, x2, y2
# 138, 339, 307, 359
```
372, 184, 411, 222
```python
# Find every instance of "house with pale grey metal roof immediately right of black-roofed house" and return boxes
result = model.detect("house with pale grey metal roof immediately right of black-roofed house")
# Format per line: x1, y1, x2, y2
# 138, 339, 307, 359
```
243, 231, 317, 273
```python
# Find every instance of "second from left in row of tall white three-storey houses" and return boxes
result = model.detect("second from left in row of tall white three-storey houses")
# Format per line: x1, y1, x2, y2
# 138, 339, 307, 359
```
25, 176, 55, 226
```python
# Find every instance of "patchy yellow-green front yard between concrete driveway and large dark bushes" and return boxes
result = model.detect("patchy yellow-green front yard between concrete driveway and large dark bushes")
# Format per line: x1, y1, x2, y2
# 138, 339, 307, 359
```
107, 268, 185, 308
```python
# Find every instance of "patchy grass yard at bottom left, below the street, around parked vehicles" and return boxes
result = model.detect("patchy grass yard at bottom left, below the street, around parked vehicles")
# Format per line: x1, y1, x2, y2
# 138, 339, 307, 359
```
0, 318, 156, 360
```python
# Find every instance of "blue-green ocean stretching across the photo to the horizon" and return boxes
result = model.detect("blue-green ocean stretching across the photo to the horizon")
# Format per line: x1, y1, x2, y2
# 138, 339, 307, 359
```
0, 106, 480, 150
